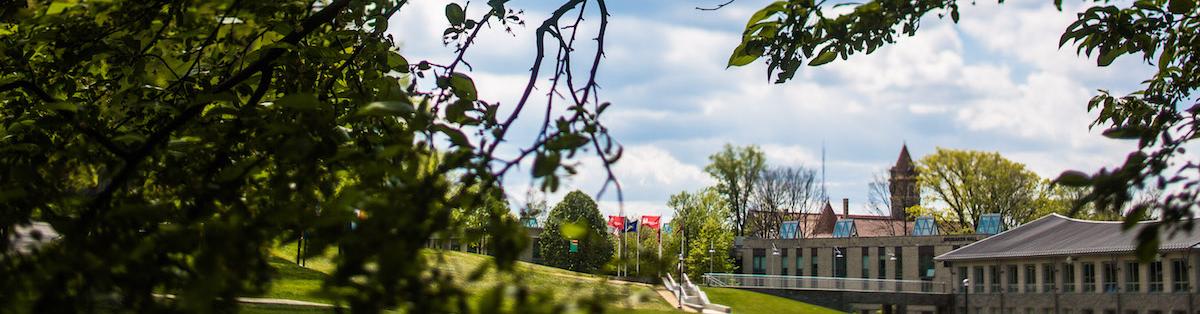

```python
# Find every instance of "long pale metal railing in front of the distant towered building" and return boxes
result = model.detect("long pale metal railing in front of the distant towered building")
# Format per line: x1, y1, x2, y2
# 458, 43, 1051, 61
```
704, 273, 949, 294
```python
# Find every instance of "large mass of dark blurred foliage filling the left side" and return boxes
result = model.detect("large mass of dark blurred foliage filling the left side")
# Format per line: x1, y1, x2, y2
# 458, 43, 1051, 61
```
0, 0, 619, 313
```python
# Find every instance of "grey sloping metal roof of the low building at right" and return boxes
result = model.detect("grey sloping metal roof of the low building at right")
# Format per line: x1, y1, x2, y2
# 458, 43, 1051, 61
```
937, 213, 1200, 261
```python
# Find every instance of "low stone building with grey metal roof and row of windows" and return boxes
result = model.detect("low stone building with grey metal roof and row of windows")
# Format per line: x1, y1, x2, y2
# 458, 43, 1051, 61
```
936, 215, 1200, 314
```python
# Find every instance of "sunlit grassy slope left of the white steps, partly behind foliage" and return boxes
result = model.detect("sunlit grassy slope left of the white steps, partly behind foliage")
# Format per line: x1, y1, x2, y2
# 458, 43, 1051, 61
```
255, 244, 678, 314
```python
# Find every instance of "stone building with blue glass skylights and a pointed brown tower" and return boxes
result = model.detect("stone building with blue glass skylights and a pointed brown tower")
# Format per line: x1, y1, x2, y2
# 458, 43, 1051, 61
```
734, 145, 986, 313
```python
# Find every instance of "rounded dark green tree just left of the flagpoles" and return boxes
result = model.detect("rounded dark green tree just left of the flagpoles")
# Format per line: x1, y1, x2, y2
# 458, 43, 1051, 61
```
538, 191, 613, 273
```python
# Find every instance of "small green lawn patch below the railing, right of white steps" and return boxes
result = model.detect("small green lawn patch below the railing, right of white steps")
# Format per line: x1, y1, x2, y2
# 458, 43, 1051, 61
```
703, 288, 841, 314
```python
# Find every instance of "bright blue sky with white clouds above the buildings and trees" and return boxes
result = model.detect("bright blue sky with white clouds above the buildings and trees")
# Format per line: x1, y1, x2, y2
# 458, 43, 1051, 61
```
390, 0, 1151, 220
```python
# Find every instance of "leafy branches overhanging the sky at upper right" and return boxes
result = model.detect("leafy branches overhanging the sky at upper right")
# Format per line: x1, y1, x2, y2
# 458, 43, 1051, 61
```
728, 0, 1200, 258
